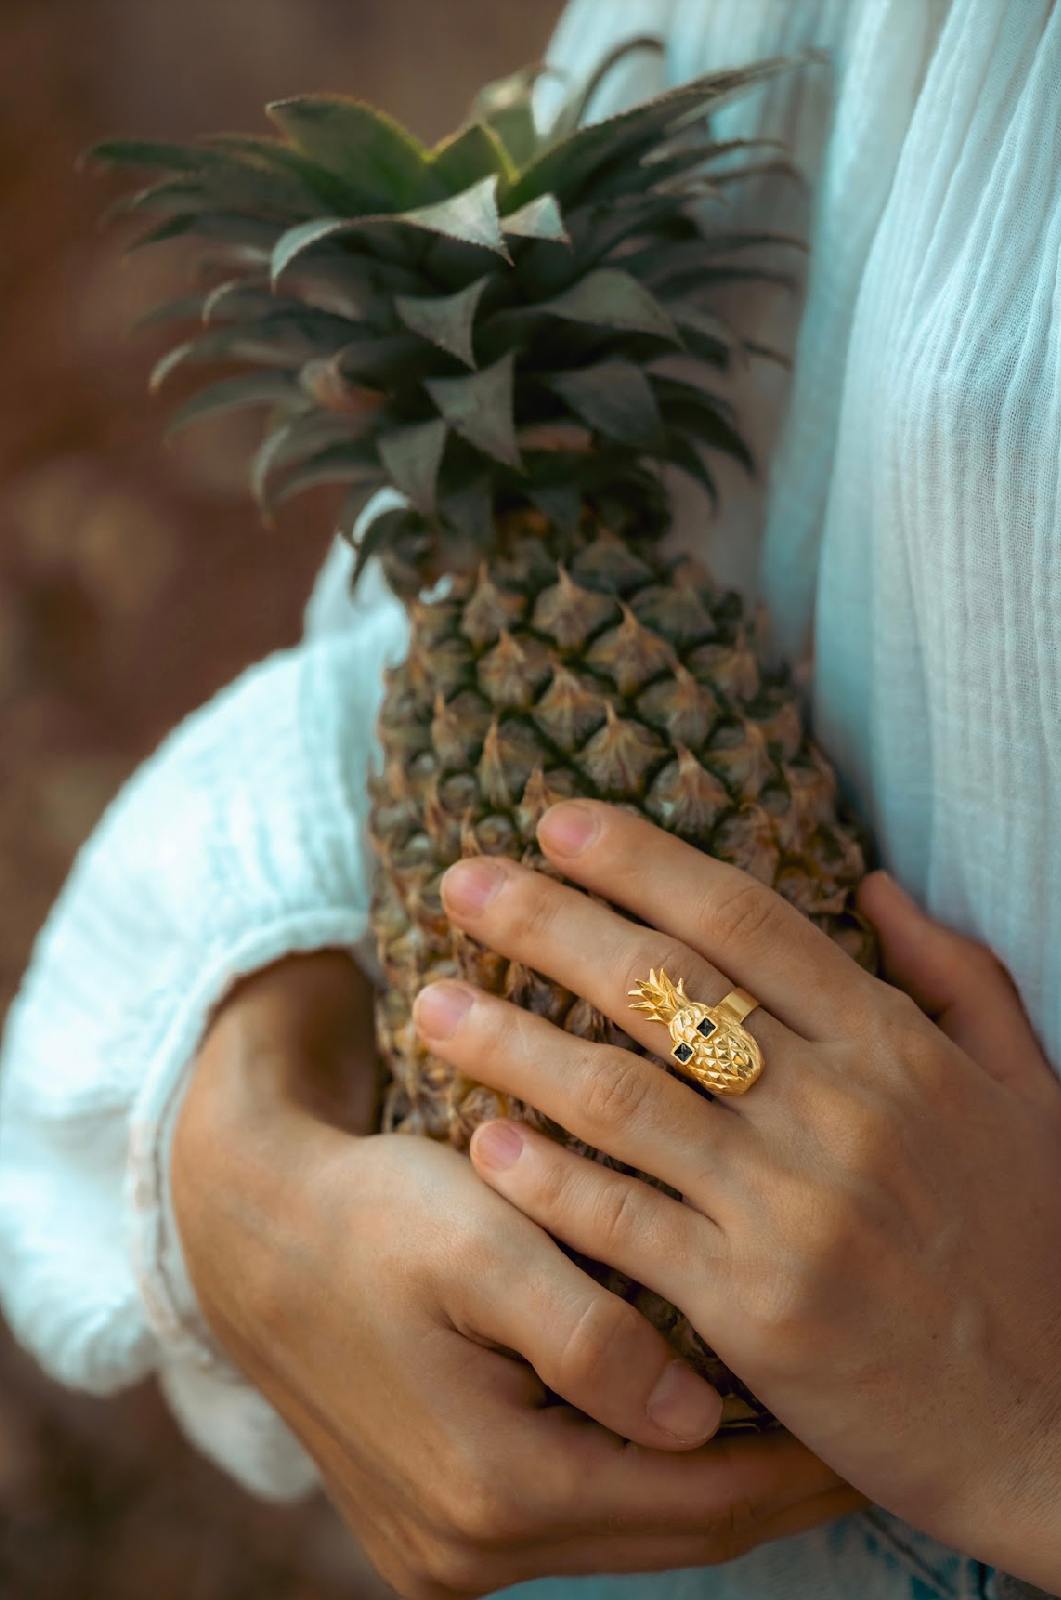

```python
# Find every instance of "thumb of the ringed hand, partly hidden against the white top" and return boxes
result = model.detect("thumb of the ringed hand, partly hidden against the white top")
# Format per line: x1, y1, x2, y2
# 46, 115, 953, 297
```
858, 872, 1061, 1110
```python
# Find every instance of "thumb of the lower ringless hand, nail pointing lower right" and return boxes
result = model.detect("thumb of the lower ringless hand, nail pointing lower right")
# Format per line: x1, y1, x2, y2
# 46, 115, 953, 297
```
445, 1203, 722, 1450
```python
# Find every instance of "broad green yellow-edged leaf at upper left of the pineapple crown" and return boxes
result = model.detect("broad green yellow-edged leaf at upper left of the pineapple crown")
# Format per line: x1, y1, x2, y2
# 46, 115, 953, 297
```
266, 94, 440, 211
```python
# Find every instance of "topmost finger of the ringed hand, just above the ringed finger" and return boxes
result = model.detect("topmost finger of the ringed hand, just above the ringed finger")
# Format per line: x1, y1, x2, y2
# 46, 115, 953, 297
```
538, 800, 872, 1042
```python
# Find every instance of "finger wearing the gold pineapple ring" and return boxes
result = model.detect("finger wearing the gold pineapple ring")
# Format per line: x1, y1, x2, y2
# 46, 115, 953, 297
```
442, 856, 795, 1081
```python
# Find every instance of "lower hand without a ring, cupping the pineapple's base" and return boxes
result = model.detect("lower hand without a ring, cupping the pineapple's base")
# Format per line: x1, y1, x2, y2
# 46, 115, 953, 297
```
173, 952, 859, 1597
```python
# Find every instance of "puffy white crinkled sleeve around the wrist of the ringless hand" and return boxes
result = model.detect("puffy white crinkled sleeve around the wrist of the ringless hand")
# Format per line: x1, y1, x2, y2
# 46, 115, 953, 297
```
0, 588, 405, 1498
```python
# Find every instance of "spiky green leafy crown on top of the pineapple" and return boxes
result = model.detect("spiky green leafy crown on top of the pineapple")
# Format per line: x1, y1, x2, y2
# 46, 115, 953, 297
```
88, 38, 799, 589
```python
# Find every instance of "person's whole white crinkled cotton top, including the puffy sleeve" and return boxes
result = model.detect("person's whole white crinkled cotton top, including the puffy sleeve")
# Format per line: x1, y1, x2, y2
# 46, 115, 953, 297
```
0, 0, 1061, 1496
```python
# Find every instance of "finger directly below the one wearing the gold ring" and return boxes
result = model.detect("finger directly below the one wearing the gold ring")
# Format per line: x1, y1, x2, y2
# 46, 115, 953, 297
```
414, 981, 744, 1209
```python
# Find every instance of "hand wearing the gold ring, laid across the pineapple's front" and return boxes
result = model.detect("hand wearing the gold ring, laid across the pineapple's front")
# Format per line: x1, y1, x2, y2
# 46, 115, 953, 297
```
418, 802, 1061, 1587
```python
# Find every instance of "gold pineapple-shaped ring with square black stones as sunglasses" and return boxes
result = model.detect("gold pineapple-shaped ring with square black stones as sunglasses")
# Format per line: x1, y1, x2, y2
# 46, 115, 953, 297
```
627, 966, 763, 1094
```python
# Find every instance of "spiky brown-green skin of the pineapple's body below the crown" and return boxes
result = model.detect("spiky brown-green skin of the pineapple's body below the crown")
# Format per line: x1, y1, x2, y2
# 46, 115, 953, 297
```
370, 509, 875, 1427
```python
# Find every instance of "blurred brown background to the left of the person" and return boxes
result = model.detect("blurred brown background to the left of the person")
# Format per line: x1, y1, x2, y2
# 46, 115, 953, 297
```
0, 0, 560, 1600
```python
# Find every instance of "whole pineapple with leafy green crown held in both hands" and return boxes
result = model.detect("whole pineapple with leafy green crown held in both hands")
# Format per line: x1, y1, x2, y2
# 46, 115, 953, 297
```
93, 40, 874, 1426
